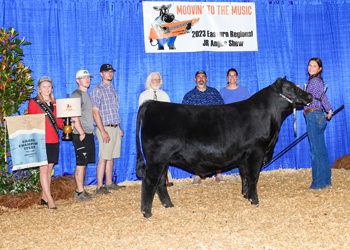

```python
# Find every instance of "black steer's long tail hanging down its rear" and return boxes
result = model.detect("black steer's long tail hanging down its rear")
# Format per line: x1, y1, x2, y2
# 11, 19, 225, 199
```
136, 103, 147, 177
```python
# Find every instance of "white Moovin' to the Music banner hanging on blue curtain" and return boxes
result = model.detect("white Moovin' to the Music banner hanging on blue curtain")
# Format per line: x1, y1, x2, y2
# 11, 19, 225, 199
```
142, 1, 258, 53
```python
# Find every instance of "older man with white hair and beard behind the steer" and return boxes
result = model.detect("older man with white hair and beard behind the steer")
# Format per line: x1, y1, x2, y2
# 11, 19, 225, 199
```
139, 72, 174, 187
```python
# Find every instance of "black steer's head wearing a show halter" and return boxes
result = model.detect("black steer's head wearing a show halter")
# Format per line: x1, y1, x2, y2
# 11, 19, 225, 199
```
271, 77, 313, 106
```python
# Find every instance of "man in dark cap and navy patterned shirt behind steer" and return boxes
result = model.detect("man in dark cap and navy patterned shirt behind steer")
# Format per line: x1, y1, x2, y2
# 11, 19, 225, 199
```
182, 70, 225, 185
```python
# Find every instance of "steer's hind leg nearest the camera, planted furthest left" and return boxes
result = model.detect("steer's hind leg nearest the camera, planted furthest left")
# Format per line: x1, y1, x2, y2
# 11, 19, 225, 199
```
141, 164, 161, 218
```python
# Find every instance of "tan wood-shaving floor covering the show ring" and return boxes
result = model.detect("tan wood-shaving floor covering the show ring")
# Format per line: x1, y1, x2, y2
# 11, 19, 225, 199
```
0, 169, 350, 249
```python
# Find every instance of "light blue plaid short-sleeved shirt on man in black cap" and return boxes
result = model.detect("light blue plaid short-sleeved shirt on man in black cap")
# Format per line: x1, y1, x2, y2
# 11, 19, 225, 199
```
91, 81, 121, 126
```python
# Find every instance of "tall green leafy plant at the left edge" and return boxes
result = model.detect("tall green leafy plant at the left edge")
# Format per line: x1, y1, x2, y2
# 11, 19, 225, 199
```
0, 28, 39, 195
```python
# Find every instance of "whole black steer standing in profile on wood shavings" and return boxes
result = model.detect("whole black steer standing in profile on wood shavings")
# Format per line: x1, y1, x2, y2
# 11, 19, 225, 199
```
136, 78, 312, 218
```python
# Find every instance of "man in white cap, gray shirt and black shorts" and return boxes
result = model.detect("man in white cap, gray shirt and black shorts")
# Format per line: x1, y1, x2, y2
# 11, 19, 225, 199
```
71, 70, 95, 201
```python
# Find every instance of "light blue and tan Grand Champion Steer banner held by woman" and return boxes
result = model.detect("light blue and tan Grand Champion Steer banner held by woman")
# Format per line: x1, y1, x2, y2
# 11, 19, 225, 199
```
6, 114, 47, 170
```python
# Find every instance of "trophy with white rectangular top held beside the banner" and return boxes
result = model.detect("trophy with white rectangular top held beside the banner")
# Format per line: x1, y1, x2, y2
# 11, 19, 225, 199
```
56, 95, 81, 141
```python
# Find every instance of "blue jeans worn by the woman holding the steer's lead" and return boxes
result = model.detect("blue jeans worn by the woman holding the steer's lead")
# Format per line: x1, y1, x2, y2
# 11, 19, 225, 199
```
305, 111, 332, 189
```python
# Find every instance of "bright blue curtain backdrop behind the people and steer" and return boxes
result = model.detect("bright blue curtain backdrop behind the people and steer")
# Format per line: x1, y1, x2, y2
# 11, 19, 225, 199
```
0, 0, 350, 185
